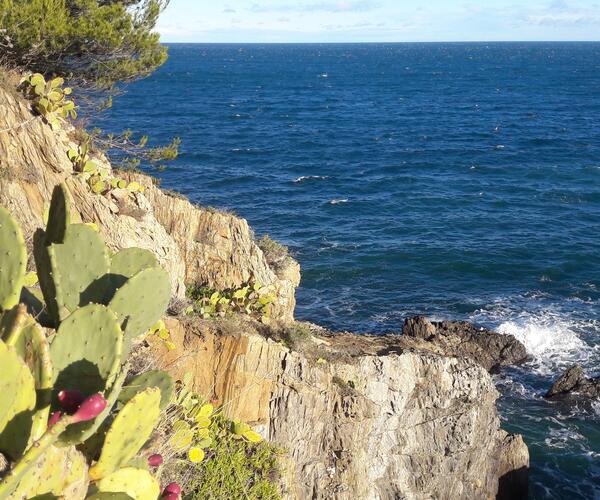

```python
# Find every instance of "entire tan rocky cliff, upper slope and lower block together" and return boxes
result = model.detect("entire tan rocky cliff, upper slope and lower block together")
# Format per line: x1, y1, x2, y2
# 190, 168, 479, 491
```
0, 81, 528, 500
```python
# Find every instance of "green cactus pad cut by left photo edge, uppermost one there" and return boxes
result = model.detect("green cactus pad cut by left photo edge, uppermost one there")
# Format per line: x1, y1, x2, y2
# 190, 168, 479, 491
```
0, 208, 27, 310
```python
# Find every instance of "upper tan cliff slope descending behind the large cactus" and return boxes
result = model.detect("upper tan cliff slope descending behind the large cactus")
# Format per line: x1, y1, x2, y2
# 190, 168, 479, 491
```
0, 88, 300, 322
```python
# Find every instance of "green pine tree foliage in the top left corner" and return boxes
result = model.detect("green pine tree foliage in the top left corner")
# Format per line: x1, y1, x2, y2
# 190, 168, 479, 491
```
0, 0, 169, 87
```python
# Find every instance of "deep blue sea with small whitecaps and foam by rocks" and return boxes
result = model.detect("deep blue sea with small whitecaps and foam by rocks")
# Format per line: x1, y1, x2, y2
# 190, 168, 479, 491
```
103, 43, 600, 499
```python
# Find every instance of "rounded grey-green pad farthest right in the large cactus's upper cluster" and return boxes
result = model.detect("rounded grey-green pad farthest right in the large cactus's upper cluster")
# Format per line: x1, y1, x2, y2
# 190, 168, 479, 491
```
109, 268, 171, 345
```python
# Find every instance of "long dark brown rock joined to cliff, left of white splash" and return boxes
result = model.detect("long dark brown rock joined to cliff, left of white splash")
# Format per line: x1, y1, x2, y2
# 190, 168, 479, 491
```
402, 316, 527, 371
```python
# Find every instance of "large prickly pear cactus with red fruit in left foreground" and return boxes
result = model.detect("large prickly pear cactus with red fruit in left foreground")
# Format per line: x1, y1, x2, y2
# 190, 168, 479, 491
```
0, 187, 173, 500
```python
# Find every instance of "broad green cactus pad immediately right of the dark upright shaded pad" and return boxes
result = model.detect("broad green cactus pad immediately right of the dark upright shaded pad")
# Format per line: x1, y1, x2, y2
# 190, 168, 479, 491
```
48, 224, 109, 321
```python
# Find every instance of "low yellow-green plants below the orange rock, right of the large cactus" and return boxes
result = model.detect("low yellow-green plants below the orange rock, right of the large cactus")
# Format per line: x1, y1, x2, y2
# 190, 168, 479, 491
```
159, 374, 280, 500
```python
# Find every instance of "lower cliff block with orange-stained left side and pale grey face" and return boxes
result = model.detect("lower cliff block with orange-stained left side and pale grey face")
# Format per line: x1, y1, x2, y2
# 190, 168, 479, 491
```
149, 319, 529, 500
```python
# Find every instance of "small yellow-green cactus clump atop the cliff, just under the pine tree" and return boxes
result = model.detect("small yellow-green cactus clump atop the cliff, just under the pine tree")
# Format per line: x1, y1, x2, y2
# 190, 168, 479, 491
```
20, 73, 77, 129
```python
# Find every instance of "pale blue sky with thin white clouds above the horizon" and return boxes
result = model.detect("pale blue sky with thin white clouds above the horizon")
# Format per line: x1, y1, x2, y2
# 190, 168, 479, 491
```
158, 0, 600, 42
